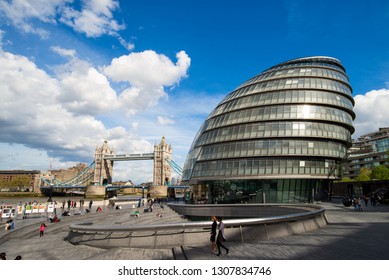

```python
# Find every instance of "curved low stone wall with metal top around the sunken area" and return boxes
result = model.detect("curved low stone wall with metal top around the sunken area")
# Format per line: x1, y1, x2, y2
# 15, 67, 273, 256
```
67, 204, 328, 248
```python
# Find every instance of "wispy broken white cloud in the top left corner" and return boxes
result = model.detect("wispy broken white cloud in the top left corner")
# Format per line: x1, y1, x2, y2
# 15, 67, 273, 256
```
0, 0, 127, 41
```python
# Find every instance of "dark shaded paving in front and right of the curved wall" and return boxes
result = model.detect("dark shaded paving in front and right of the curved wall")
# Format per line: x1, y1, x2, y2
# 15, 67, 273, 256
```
185, 203, 389, 260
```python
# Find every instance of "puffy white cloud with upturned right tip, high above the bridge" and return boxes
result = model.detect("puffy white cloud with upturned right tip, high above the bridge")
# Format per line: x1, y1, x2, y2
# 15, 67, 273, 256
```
103, 50, 190, 114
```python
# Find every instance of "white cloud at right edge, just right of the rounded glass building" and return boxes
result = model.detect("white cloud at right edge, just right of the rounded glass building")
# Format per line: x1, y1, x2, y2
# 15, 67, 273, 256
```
353, 89, 389, 138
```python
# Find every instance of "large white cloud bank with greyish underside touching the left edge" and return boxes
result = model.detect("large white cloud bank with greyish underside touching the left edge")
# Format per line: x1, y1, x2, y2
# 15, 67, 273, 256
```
0, 47, 105, 158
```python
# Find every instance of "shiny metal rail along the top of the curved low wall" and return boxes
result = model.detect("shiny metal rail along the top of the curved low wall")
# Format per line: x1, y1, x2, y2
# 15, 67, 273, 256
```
69, 205, 325, 232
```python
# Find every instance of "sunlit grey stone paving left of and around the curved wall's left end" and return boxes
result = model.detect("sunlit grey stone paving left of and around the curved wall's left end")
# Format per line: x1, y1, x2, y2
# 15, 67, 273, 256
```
0, 201, 182, 260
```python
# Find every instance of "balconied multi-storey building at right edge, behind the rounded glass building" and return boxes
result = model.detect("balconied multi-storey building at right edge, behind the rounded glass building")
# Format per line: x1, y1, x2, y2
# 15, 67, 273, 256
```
343, 127, 389, 179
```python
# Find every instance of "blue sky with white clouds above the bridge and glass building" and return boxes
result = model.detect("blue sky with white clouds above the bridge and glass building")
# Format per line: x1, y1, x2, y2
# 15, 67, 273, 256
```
0, 0, 389, 183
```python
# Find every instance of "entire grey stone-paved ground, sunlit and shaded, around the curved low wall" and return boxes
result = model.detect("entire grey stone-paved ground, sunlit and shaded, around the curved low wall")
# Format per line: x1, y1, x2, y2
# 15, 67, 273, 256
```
0, 200, 389, 260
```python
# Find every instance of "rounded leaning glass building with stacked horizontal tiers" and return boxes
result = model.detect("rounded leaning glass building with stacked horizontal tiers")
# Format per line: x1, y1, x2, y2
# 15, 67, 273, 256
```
183, 56, 355, 203
